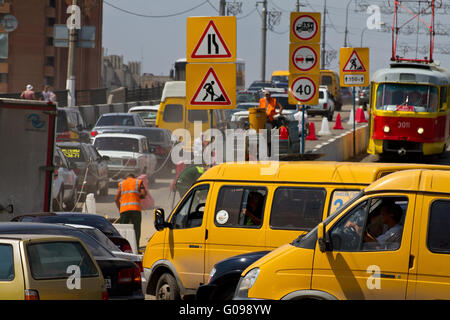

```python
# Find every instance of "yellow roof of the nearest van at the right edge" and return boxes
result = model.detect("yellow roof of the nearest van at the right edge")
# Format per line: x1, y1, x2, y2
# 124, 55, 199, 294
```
365, 166, 450, 194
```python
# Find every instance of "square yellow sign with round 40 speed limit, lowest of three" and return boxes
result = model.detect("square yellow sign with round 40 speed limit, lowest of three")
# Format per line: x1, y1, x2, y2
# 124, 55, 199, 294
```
289, 74, 319, 105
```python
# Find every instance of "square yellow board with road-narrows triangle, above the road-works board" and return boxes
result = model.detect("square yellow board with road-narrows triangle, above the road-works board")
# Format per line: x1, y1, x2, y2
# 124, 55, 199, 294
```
186, 16, 236, 63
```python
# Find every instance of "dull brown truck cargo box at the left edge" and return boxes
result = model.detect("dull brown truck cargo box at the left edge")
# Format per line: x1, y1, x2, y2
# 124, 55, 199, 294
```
0, 99, 57, 221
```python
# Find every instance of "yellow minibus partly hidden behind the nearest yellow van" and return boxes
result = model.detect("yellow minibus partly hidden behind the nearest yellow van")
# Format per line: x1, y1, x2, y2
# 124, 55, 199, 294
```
143, 161, 444, 299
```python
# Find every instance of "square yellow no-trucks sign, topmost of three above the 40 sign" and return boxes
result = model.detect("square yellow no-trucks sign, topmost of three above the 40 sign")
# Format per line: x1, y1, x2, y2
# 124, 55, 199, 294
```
290, 12, 321, 43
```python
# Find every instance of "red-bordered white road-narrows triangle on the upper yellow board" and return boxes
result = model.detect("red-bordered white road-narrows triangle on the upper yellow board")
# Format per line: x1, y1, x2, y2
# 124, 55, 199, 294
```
191, 20, 232, 58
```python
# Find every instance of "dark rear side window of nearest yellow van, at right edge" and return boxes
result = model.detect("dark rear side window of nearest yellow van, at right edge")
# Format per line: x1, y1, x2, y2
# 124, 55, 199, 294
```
427, 200, 450, 254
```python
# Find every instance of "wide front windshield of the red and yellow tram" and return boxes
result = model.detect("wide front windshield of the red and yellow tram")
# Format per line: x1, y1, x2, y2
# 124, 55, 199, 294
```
376, 83, 438, 112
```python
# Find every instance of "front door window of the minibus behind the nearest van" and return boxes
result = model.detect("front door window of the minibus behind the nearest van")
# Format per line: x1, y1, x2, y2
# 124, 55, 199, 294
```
171, 185, 209, 229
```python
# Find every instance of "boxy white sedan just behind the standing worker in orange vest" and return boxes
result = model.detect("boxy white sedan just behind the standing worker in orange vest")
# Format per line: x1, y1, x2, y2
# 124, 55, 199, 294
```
92, 133, 156, 182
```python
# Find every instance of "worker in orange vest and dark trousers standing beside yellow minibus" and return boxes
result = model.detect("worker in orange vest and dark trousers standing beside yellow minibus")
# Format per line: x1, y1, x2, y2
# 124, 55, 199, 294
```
115, 173, 147, 248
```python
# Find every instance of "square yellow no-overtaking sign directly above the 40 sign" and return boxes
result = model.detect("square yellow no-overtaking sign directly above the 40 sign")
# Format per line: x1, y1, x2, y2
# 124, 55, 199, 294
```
289, 43, 320, 74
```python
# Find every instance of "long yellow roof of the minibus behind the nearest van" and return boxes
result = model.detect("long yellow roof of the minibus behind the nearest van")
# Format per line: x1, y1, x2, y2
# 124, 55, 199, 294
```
198, 161, 450, 185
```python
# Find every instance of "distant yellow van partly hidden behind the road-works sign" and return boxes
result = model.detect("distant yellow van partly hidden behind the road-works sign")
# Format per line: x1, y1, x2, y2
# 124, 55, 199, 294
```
156, 81, 226, 145
